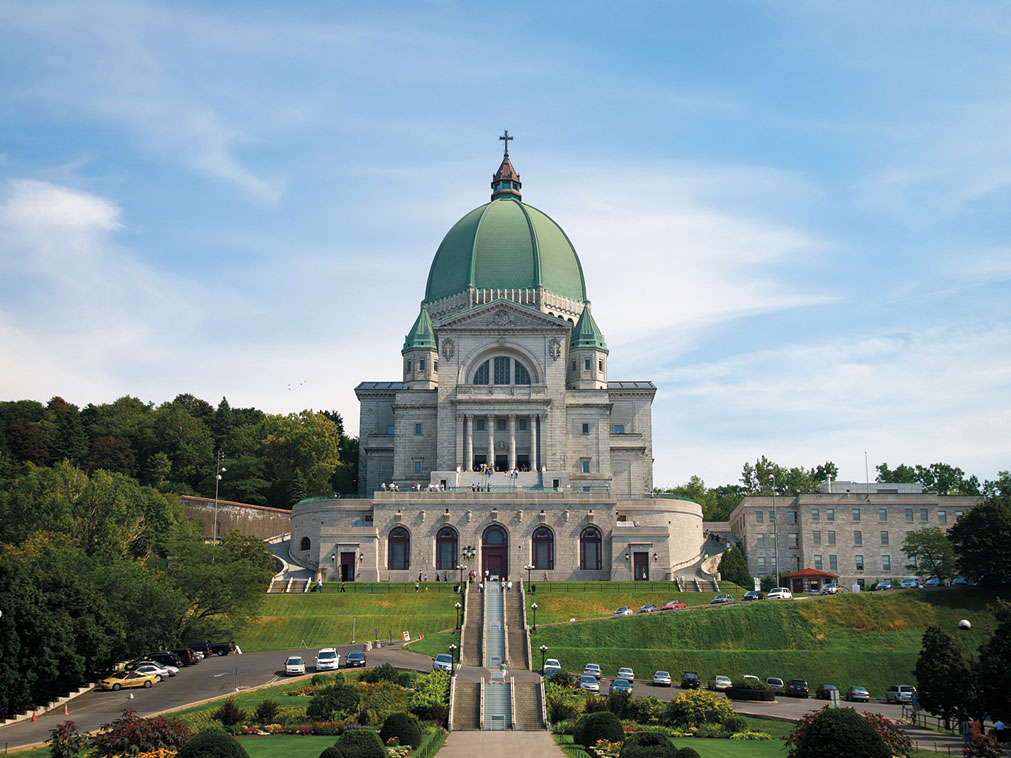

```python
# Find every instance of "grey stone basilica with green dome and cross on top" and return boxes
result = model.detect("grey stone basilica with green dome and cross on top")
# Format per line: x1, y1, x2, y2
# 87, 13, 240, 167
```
291, 139, 703, 581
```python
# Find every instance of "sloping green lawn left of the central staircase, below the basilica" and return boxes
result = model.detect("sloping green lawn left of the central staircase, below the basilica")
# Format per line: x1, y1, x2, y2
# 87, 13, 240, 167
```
236, 582, 459, 653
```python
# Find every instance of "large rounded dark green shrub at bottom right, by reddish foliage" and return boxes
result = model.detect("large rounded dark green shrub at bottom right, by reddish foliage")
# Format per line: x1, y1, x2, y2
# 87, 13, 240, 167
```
787, 707, 892, 758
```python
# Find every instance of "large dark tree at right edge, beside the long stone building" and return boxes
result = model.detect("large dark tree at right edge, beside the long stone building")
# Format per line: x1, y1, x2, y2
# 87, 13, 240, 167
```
947, 499, 1011, 586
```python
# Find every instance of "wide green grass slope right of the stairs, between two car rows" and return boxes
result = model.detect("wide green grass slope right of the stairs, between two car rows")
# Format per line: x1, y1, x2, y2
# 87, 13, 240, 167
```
534, 589, 995, 696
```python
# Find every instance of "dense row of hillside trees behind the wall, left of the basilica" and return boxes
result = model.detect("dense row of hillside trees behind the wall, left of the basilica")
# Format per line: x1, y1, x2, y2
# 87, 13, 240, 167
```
0, 394, 358, 507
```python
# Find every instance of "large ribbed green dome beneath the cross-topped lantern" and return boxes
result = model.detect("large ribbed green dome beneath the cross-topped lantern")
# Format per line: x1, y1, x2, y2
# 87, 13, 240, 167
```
425, 197, 586, 302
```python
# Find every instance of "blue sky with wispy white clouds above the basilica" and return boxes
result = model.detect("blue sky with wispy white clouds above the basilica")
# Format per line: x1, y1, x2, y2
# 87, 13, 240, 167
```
0, 0, 1011, 486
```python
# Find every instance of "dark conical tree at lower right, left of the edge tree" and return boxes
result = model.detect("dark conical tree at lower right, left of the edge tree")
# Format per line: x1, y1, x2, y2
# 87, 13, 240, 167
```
914, 625, 976, 729
